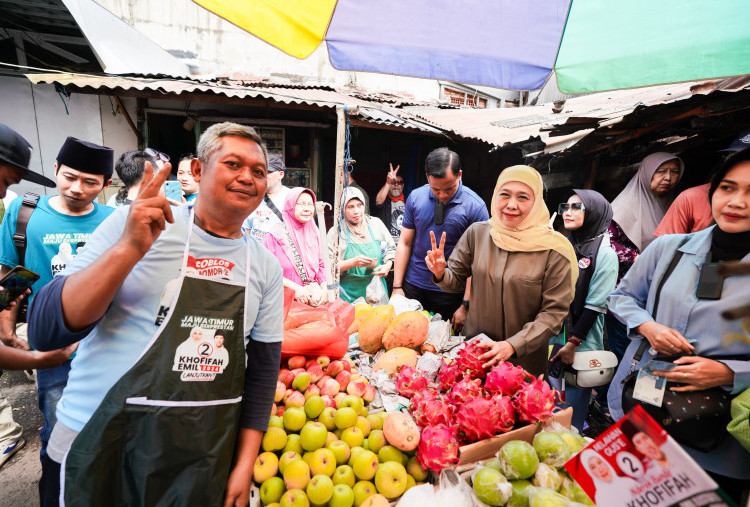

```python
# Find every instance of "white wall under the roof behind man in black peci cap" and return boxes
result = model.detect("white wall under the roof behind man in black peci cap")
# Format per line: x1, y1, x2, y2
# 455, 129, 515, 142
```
0, 76, 137, 199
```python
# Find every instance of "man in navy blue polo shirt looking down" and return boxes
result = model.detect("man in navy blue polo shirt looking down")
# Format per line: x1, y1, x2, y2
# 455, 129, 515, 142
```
393, 148, 489, 333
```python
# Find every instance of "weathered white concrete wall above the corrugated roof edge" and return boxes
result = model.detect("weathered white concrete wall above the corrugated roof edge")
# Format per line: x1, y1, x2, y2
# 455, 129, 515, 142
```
96, 0, 440, 100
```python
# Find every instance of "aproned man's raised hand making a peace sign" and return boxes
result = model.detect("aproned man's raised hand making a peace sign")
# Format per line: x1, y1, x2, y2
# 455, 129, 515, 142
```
122, 162, 174, 257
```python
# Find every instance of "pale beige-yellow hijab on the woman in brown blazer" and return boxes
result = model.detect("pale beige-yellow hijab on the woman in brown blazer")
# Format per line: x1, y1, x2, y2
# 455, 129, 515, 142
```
490, 165, 578, 292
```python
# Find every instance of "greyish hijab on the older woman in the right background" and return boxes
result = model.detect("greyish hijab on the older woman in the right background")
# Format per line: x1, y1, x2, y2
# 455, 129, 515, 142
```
612, 151, 685, 252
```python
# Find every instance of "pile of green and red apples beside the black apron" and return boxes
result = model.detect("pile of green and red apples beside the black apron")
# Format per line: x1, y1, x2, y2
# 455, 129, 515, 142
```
253, 356, 427, 507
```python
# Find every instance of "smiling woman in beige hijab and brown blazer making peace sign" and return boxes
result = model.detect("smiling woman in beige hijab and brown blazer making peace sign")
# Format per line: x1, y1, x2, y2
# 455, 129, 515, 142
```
425, 166, 578, 376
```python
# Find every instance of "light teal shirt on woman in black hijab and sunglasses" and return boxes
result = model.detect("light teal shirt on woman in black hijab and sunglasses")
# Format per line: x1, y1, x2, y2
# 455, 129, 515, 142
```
550, 235, 618, 352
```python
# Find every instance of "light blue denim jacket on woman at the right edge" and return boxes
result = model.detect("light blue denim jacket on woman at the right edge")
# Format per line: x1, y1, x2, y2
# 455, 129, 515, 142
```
607, 226, 750, 479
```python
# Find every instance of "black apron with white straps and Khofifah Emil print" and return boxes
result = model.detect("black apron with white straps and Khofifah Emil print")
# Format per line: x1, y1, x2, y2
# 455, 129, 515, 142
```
60, 212, 250, 506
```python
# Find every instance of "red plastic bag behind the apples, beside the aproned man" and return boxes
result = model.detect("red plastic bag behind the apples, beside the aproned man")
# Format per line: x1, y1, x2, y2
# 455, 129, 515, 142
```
281, 289, 354, 359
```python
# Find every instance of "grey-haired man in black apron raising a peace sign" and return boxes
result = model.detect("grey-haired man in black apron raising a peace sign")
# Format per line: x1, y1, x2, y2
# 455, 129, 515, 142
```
29, 123, 283, 505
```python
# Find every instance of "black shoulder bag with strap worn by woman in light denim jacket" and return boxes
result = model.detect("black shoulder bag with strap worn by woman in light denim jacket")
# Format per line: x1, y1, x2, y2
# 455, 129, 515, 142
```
622, 241, 748, 452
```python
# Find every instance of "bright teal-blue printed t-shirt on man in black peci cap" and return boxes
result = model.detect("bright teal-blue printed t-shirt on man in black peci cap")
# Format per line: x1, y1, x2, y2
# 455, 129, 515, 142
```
0, 195, 114, 299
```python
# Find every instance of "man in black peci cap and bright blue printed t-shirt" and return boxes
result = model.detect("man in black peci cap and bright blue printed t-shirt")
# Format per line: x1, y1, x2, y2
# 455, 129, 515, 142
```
0, 137, 114, 480
